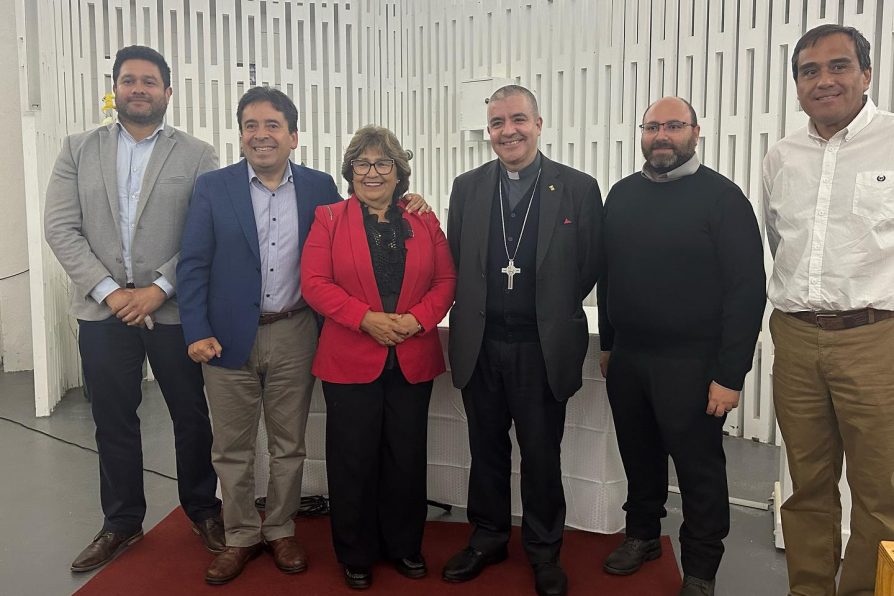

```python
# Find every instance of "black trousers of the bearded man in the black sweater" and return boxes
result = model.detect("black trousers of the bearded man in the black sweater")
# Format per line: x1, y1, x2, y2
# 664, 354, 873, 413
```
606, 348, 729, 579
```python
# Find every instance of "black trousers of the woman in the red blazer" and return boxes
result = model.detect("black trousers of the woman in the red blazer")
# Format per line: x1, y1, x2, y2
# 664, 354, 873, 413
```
323, 366, 433, 567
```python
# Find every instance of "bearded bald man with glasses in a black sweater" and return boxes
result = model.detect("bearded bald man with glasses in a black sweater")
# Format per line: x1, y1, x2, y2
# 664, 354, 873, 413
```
599, 97, 766, 596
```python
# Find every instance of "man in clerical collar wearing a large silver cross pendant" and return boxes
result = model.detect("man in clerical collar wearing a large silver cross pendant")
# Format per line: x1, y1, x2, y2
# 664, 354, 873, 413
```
443, 85, 602, 595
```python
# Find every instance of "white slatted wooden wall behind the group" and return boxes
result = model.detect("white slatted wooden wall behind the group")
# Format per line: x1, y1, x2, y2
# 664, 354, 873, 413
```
17, 0, 894, 441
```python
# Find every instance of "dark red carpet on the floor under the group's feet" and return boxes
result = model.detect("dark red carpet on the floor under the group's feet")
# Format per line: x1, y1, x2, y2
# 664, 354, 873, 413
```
77, 507, 681, 596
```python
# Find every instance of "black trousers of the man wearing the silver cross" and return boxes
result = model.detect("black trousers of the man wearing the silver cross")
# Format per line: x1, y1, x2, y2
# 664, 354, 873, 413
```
462, 338, 565, 564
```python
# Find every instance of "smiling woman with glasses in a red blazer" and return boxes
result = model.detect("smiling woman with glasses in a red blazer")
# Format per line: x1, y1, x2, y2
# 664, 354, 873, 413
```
301, 126, 456, 588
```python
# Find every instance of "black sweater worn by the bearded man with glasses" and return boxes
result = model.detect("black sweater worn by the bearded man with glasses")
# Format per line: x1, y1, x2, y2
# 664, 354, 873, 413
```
599, 166, 766, 390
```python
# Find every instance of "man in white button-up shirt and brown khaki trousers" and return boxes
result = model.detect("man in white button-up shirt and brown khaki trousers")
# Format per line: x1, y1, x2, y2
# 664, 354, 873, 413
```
763, 25, 894, 596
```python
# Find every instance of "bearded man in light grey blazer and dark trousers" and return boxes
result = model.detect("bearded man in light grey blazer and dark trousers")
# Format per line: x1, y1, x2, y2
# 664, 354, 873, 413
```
44, 46, 224, 572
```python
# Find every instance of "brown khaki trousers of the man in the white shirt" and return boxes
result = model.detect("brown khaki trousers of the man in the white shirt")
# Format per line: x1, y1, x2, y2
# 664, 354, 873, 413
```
770, 311, 894, 596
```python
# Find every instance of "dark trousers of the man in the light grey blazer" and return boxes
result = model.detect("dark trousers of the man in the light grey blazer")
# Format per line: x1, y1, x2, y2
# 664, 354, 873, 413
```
78, 317, 220, 532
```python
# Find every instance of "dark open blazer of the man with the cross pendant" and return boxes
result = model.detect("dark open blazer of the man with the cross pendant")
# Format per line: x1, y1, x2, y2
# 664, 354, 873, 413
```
447, 156, 602, 401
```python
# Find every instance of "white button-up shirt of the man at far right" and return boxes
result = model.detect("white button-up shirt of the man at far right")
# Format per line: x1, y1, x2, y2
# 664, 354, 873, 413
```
763, 98, 894, 312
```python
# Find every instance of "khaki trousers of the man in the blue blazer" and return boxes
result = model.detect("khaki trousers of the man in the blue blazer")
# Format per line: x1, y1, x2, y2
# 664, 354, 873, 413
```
202, 308, 317, 547
